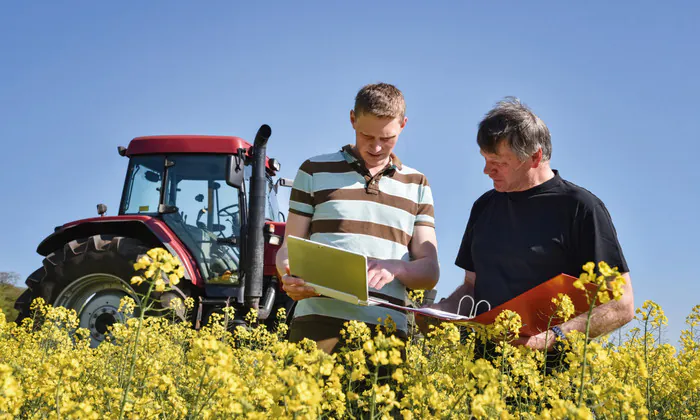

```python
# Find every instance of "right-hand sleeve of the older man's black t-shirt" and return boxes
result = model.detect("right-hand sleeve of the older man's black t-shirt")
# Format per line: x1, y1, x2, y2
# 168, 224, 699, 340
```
576, 203, 629, 274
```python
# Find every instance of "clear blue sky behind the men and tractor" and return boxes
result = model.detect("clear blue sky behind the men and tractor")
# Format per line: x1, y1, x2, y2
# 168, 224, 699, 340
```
0, 1, 700, 342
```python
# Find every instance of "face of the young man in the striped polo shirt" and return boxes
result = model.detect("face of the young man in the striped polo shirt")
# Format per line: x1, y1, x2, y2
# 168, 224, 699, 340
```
350, 111, 408, 168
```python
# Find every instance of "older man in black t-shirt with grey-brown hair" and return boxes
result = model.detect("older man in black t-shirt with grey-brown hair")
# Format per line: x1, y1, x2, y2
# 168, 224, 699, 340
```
420, 99, 634, 350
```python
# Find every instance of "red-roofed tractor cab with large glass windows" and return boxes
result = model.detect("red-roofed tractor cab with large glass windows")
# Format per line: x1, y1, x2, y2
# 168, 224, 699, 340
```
119, 136, 284, 296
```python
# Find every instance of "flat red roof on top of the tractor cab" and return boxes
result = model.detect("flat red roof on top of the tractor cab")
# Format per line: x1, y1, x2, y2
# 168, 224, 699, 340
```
126, 135, 273, 170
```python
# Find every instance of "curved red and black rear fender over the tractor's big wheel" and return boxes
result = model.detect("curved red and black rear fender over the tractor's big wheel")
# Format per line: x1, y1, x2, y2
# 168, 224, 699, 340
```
36, 215, 204, 287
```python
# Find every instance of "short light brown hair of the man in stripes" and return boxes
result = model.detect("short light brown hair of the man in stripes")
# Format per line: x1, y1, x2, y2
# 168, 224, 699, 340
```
355, 83, 406, 121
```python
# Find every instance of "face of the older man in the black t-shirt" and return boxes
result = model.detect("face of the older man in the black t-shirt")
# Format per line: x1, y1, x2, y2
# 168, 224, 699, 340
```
481, 141, 536, 192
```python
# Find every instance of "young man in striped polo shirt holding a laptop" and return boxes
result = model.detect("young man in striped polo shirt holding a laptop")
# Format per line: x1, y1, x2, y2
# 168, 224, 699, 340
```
276, 83, 439, 353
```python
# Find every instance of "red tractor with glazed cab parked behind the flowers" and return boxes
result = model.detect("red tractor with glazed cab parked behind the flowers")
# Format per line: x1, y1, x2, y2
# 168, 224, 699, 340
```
15, 125, 293, 346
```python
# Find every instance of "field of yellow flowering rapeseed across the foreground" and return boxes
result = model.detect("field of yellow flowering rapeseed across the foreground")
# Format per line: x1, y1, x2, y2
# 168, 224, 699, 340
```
0, 250, 700, 419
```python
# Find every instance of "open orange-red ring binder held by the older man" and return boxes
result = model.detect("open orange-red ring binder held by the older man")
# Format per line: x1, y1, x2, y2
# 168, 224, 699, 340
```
370, 274, 609, 336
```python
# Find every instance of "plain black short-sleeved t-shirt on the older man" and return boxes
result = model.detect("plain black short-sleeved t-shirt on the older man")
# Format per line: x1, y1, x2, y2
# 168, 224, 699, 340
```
455, 170, 629, 312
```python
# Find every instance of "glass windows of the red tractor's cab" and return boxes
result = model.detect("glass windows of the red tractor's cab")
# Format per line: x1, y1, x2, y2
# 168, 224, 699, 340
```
120, 155, 278, 285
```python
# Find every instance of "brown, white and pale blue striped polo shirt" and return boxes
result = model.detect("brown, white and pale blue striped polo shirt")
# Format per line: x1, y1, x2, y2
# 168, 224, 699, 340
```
289, 145, 435, 332
